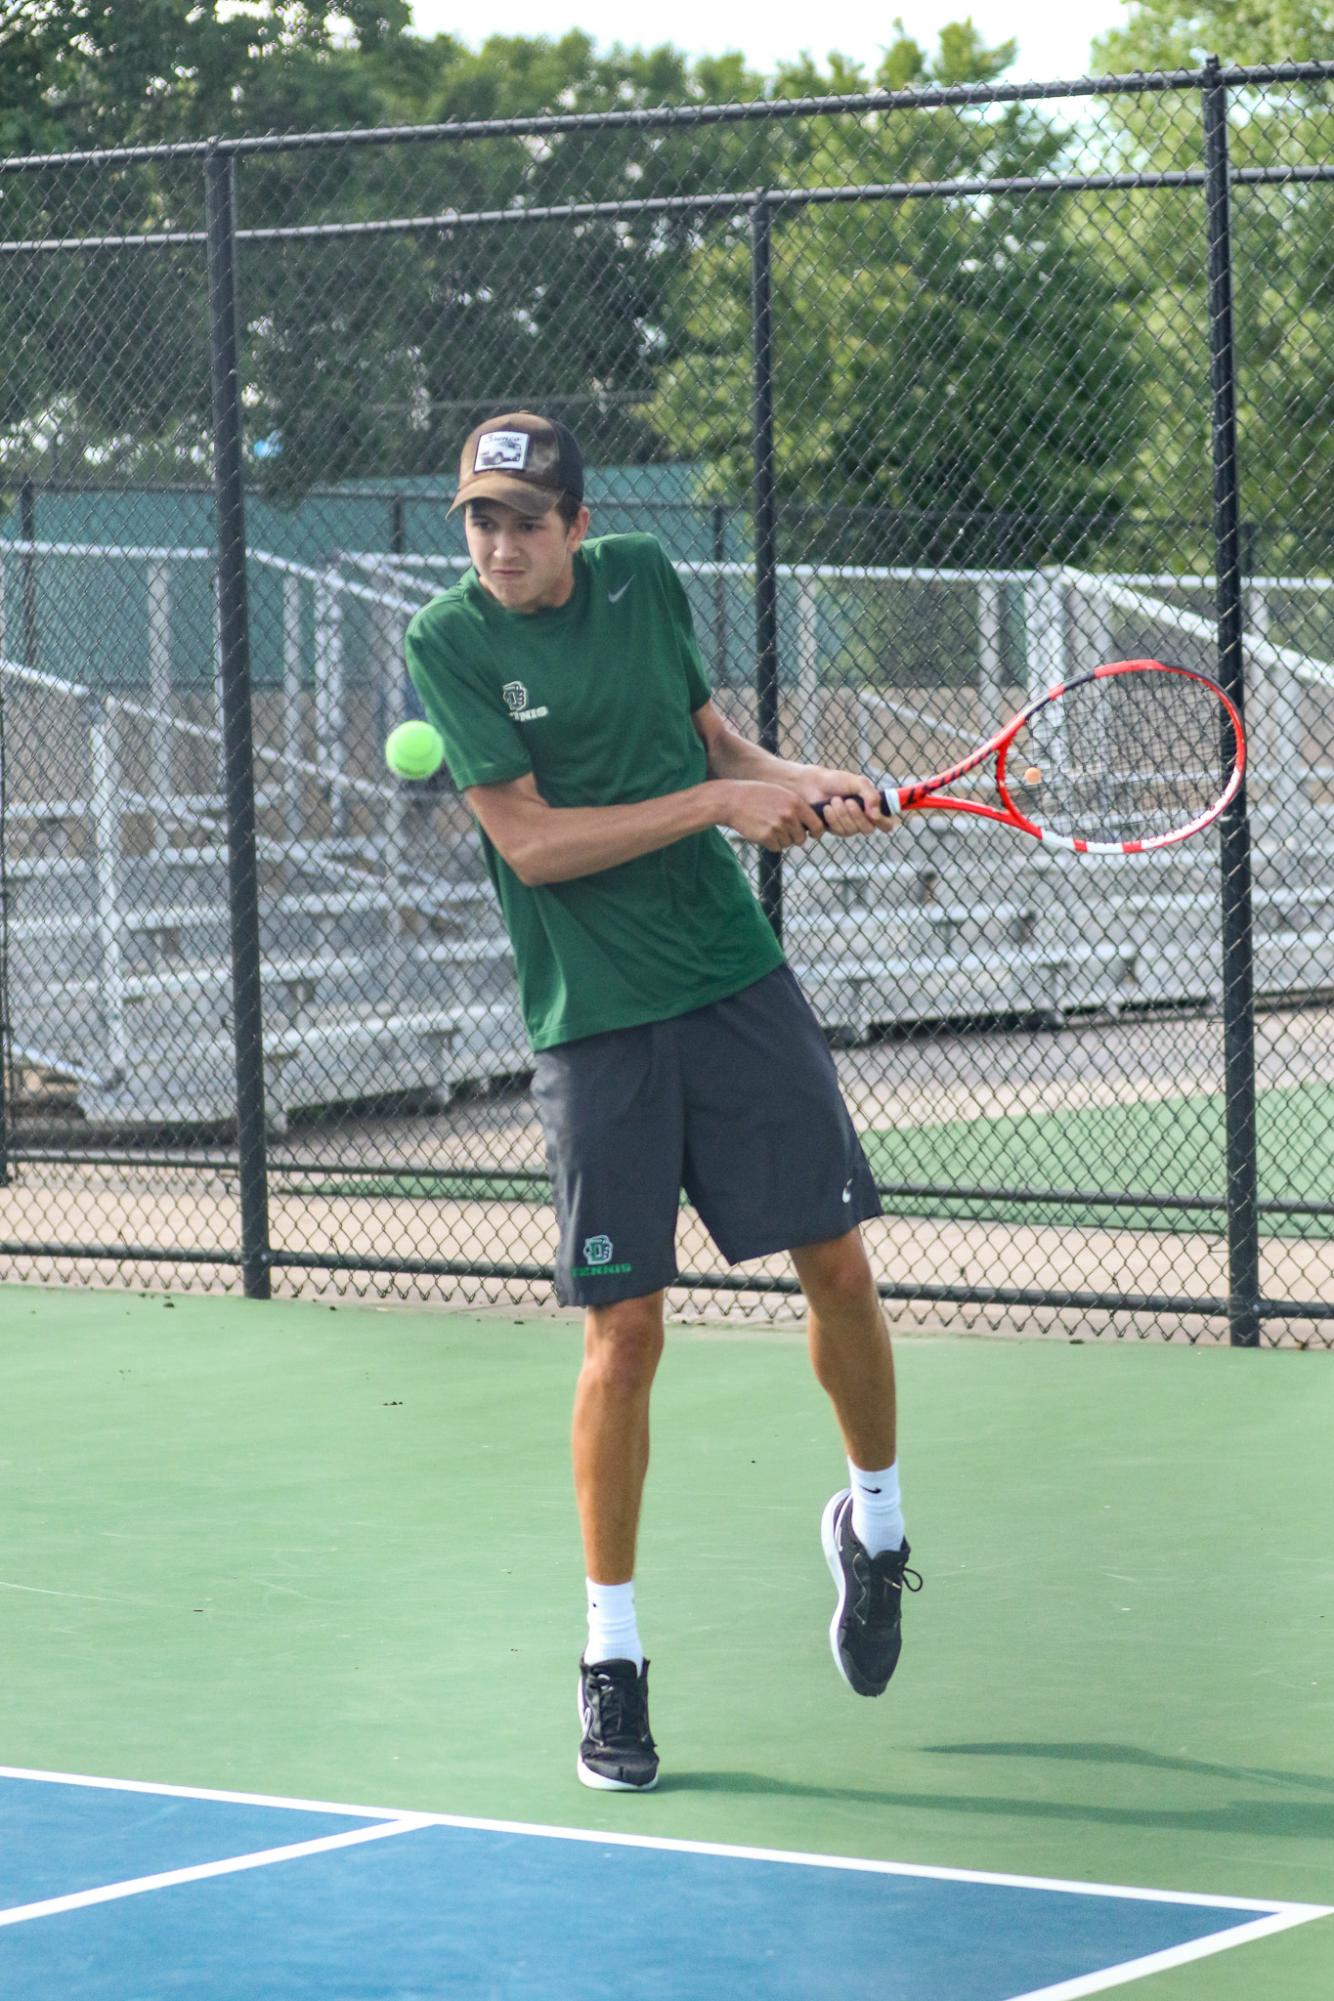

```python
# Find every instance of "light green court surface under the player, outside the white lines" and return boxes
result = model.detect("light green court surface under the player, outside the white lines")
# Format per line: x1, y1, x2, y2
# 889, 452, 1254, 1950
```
0, 1287, 1334, 2001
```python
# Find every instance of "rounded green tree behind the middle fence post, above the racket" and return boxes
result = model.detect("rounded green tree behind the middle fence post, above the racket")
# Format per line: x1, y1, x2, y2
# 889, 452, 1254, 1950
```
648, 24, 1138, 564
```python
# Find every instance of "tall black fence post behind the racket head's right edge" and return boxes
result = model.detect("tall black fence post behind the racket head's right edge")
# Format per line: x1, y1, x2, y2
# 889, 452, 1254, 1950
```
1204, 56, 1260, 1349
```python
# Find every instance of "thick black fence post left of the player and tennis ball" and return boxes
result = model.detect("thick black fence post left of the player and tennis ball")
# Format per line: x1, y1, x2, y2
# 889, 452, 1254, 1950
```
204, 148, 270, 1299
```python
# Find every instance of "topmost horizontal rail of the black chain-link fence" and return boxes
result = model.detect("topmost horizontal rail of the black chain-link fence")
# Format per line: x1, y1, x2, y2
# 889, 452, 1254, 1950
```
0, 60, 1334, 174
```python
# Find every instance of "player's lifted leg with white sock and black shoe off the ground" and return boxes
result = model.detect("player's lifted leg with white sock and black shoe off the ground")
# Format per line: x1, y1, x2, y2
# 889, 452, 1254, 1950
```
792, 1231, 920, 1695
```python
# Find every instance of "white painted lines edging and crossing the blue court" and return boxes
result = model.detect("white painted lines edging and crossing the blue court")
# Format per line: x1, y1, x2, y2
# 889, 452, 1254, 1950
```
0, 1765, 1334, 2001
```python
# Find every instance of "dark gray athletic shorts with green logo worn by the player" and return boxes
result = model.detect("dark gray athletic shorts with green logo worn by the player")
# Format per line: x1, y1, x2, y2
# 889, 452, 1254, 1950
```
532, 966, 880, 1307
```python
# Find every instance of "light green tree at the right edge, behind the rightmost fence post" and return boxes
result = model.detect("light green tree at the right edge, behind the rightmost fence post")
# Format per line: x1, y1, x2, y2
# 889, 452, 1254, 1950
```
1096, 0, 1334, 572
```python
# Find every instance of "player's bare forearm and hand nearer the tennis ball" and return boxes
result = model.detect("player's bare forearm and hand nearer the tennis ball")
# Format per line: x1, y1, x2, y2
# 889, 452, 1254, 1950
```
464, 772, 824, 888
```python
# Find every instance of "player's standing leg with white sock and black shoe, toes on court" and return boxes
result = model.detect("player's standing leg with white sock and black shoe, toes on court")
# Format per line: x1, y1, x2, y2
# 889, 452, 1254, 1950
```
572, 1293, 662, 1793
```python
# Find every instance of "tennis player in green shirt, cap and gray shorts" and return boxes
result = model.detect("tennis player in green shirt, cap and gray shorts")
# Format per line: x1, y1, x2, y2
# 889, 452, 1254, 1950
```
406, 410, 920, 1791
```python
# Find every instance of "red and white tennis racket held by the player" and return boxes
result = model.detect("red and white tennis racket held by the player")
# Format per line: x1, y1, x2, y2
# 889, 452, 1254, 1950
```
828, 660, 1246, 854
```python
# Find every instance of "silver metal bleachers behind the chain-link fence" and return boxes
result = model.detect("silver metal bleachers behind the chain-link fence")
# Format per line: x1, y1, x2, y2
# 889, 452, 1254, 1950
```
0, 544, 1334, 1129
